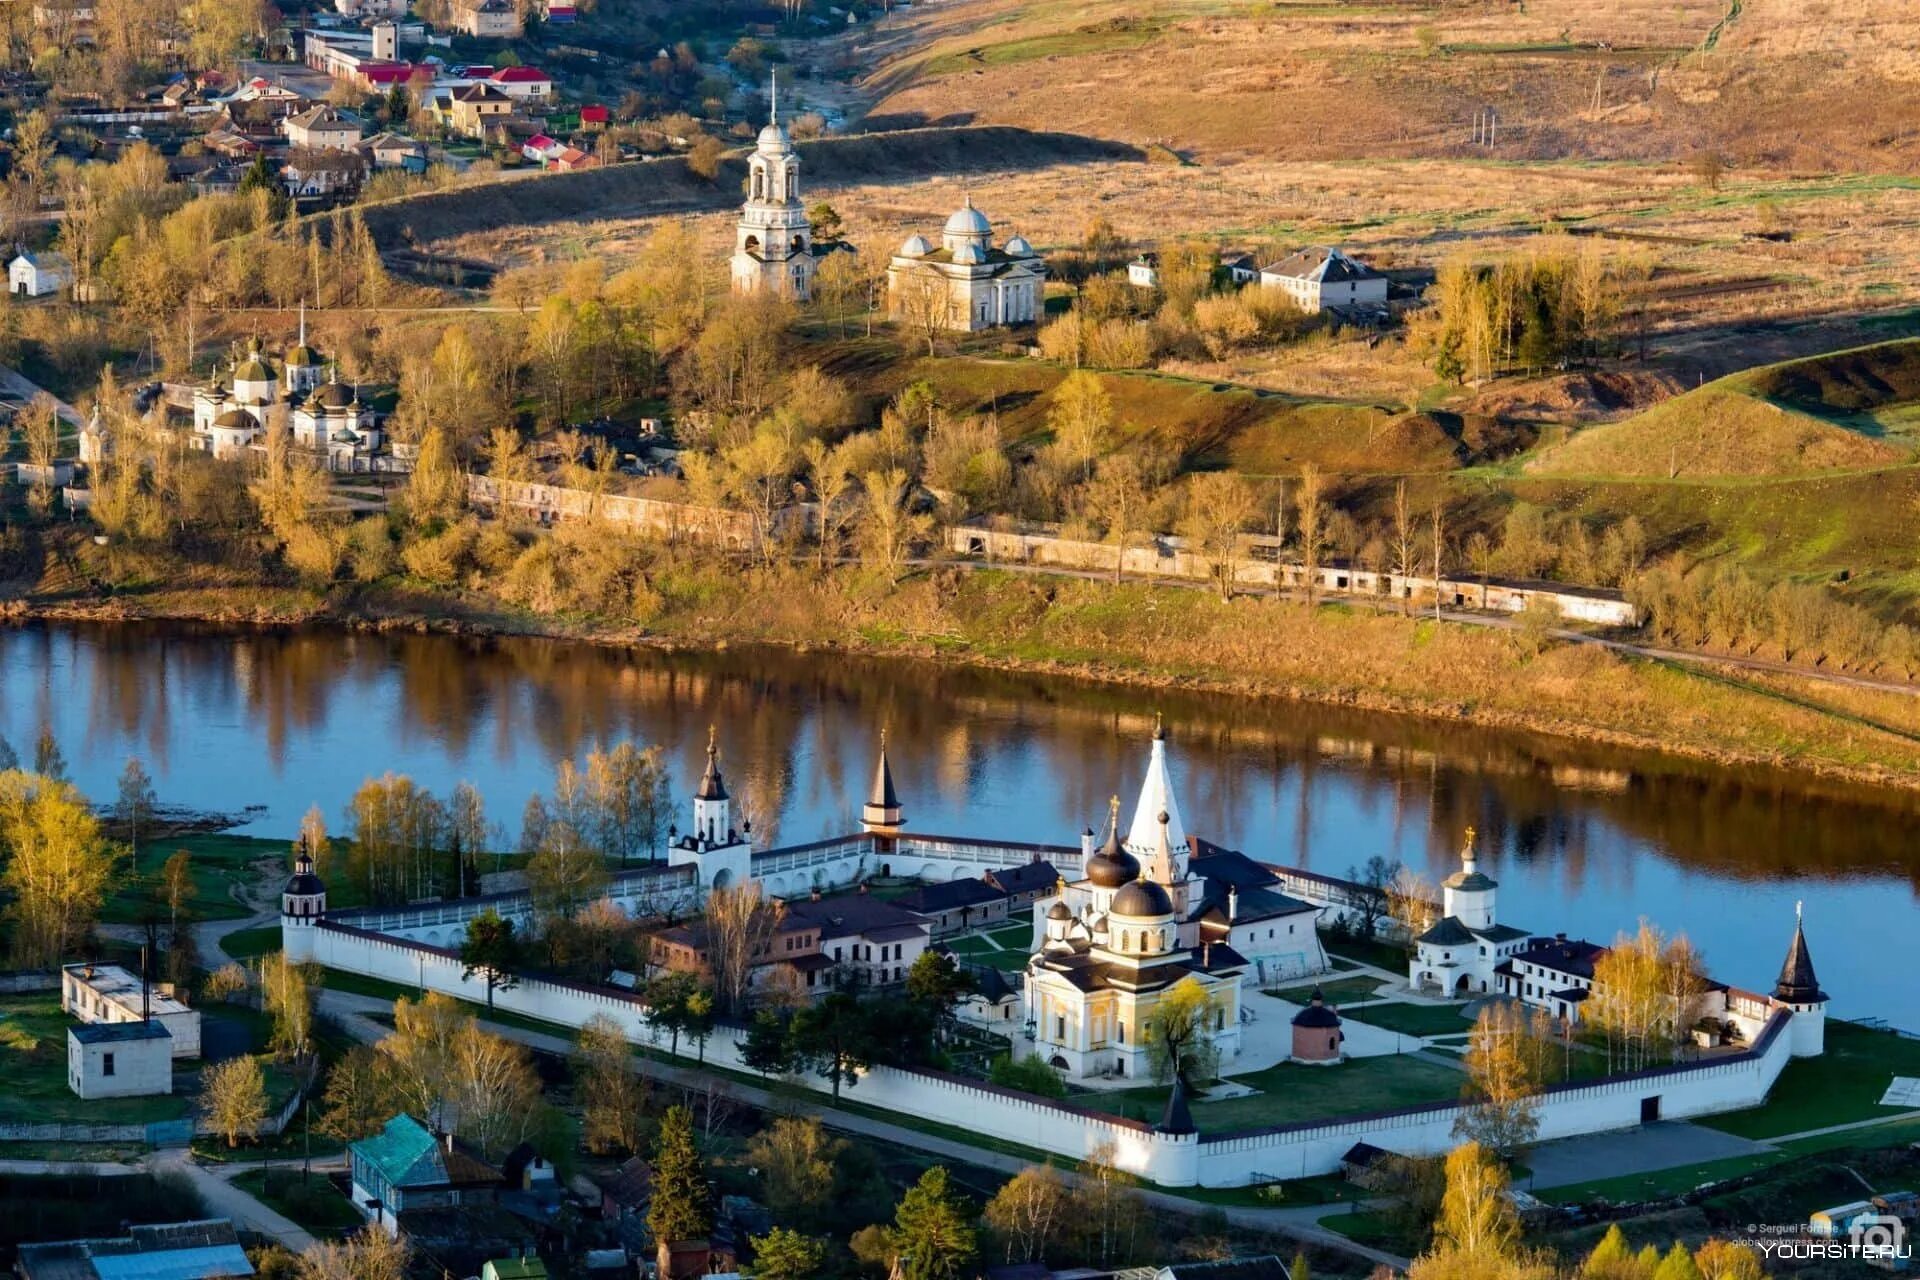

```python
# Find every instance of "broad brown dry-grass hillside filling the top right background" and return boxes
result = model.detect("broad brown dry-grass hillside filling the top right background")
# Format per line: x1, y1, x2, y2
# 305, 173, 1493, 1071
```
852, 0, 1920, 171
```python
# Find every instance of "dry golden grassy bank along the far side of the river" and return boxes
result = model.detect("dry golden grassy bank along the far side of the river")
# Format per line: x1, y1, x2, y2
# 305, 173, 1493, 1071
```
11, 557, 1920, 789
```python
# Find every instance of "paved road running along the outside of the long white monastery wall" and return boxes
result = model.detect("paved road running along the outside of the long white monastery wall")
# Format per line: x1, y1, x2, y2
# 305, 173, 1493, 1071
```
319, 990, 1407, 1270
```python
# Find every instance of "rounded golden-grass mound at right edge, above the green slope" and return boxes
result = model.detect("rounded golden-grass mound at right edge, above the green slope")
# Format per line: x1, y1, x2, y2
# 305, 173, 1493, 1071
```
1526, 342, 1920, 480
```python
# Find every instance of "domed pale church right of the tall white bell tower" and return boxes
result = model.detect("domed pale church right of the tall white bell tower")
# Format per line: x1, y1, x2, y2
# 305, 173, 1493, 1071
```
887, 196, 1046, 334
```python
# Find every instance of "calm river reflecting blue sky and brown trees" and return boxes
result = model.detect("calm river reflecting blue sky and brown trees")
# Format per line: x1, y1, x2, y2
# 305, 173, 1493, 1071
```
0, 624, 1920, 1029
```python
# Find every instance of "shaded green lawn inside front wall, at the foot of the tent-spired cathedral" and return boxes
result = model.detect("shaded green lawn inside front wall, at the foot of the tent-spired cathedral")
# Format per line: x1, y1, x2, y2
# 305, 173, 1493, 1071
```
1073, 1054, 1467, 1132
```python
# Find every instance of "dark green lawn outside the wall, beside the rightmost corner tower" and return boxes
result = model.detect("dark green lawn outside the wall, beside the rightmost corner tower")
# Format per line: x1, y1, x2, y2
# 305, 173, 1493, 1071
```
1697, 1019, 1920, 1138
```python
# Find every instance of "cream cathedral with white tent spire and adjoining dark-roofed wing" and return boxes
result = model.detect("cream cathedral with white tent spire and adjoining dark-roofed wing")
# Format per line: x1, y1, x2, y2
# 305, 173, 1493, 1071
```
1023, 727, 1327, 1079
